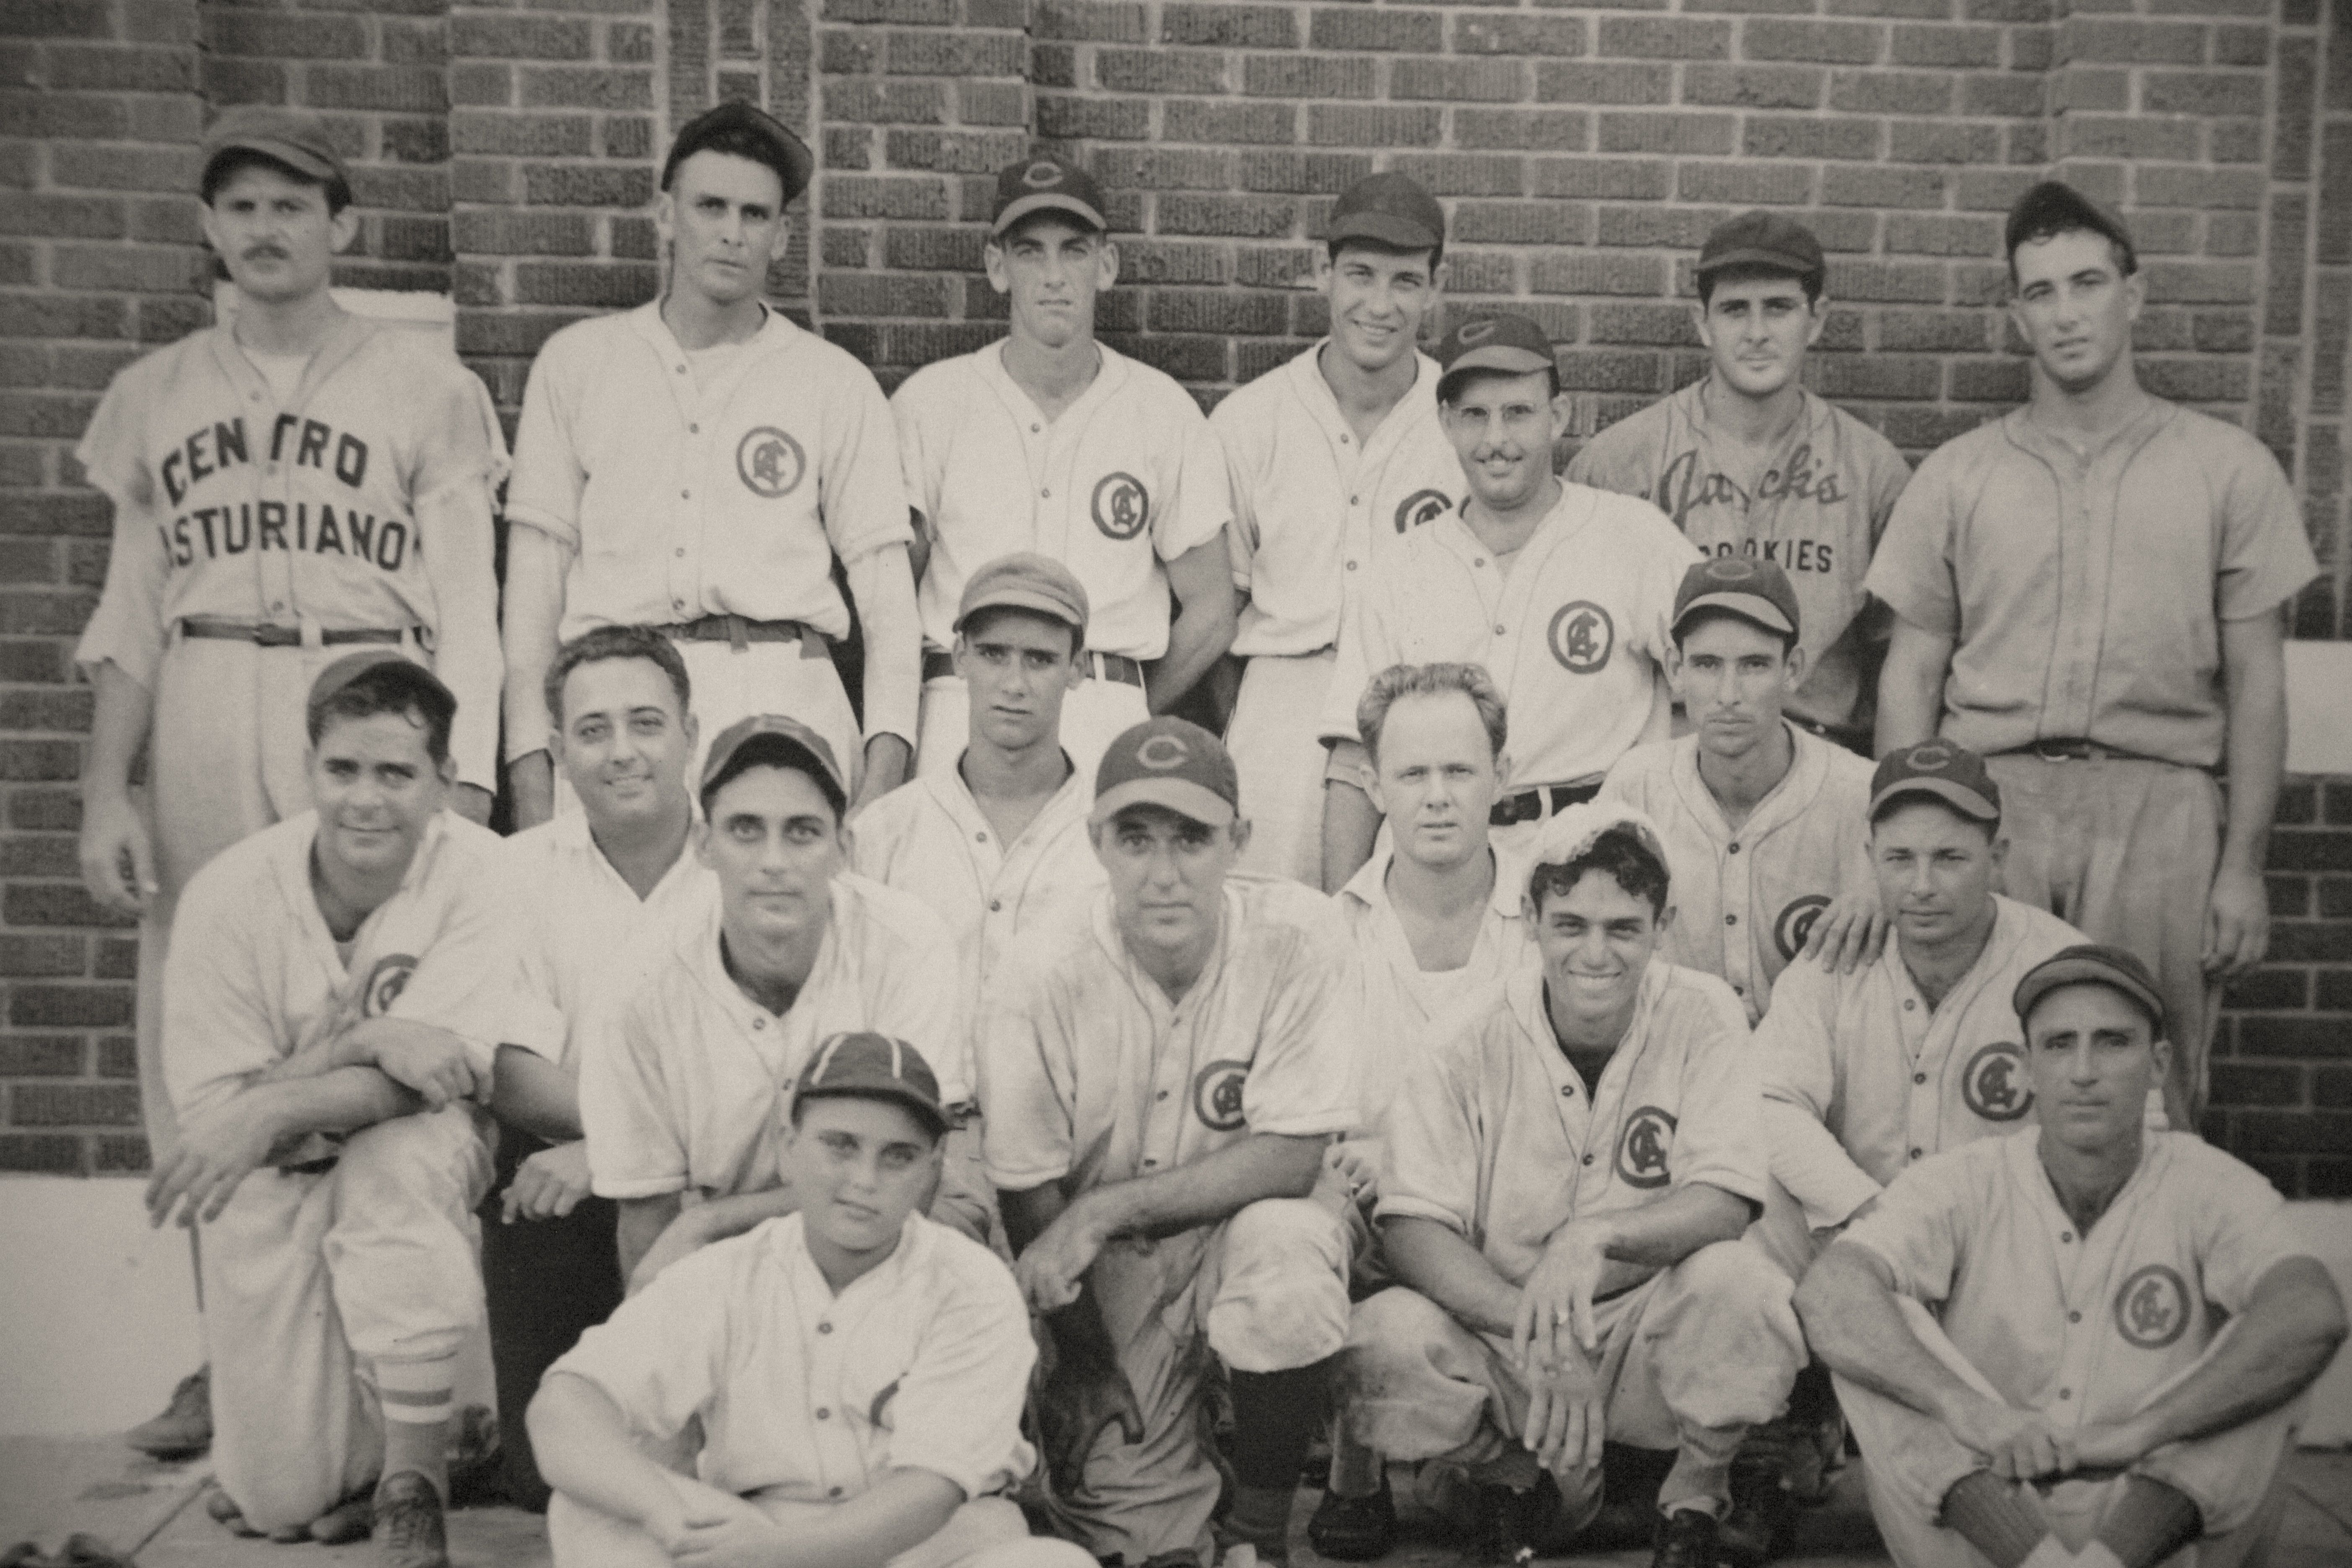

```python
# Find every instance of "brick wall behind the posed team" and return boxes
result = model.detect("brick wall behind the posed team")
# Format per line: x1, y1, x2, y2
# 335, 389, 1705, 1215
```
0, 0, 2352, 1194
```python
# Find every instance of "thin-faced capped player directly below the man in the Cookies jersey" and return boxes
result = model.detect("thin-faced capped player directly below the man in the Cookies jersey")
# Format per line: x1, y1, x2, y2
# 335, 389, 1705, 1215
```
1602, 555, 1886, 1023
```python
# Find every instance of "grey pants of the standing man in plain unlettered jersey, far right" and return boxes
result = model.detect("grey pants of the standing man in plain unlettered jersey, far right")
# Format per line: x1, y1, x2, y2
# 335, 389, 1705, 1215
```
1985, 752, 2223, 1131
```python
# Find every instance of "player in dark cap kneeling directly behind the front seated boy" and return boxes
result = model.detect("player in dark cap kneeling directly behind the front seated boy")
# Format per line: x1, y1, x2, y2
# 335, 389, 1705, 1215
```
579, 714, 985, 1293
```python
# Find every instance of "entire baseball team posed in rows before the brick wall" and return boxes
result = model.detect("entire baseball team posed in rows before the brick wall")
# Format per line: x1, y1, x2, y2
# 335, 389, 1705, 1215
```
64, 88, 2345, 1568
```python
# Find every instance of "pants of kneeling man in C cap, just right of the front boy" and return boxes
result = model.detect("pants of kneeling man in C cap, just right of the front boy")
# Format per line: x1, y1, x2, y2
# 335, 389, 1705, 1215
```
1047, 1182, 1348, 1563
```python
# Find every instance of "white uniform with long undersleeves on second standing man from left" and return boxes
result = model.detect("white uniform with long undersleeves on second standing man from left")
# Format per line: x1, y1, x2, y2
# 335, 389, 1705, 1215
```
505, 301, 917, 771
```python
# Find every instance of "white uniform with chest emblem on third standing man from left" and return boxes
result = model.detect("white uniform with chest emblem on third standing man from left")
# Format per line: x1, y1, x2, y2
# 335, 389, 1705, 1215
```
891, 343, 1228, 781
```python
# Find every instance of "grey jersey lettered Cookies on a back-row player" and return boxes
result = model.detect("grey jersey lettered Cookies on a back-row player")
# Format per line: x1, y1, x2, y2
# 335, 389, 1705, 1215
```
1566, 376, 1910, 729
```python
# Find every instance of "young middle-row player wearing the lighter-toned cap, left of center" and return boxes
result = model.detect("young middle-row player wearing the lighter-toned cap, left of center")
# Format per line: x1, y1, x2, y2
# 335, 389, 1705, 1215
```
849, 552, 1103, 1100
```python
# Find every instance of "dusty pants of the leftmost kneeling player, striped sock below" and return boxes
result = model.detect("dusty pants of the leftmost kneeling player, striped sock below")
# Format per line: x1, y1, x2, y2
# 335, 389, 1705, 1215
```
202, 1105, 489, 1530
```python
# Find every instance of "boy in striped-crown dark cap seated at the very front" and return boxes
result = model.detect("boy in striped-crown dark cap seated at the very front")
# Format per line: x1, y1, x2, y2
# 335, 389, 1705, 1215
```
529, 1034, 1091, 1568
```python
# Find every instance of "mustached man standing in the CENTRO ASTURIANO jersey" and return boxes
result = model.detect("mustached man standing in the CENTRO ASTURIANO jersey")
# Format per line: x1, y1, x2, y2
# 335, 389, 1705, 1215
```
75, 108, 505, 1450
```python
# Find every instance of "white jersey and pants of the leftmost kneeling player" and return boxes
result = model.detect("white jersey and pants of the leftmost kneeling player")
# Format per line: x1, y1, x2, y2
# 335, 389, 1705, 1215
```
162, 811, 505, 1530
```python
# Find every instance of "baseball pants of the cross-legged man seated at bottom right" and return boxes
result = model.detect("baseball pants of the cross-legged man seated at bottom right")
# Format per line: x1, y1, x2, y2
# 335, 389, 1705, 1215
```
1837, 1297, 2303, 1568
